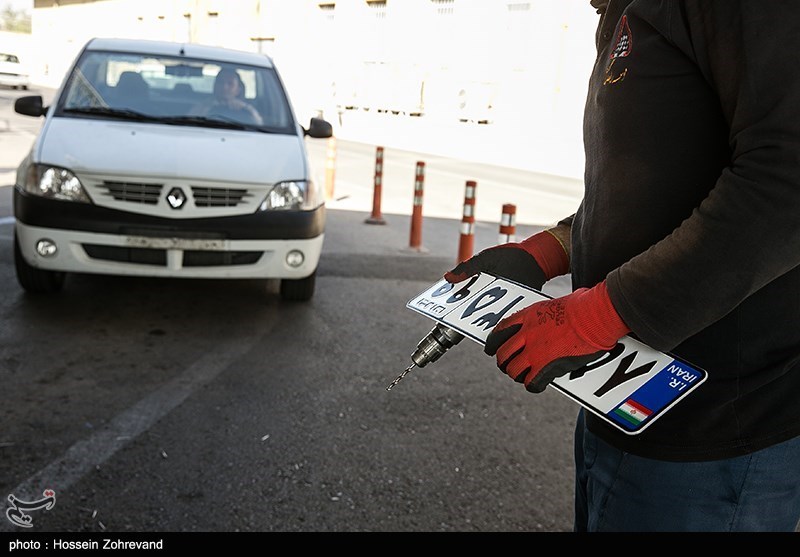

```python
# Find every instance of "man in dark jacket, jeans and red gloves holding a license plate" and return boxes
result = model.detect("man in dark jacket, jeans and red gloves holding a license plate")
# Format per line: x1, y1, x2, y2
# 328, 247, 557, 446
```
445, 0, 800, 531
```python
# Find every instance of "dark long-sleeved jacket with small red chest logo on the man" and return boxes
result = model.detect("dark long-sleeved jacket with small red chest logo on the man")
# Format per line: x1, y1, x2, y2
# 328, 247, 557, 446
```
568, 0, 800, 461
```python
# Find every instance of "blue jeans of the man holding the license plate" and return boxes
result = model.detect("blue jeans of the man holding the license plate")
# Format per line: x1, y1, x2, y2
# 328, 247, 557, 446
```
574, 409, 800, 532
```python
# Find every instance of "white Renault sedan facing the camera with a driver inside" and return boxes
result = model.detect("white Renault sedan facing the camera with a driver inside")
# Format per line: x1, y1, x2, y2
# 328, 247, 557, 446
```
14, 39, 332, 300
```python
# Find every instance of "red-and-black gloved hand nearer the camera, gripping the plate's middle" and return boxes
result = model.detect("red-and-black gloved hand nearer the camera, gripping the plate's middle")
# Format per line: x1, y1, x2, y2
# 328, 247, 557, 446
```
483, 281, 630, 393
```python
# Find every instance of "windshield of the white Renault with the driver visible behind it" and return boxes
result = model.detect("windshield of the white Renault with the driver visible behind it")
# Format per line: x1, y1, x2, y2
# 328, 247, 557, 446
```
57, 51, 294, 133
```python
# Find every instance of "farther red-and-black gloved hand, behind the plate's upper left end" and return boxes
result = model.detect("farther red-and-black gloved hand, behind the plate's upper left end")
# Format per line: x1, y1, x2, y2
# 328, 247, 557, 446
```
444, 231, 569, 290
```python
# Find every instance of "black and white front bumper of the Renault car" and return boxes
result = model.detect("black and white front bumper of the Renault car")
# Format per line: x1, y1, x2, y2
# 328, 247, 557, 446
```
14, 189, 325, 279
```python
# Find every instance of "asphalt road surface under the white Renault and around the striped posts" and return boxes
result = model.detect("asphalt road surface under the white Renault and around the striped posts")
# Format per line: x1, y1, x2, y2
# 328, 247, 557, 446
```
0, 86, 588, 533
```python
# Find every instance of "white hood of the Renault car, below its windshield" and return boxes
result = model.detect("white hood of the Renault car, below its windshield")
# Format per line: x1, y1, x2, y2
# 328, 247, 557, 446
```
36, 117, 307, 184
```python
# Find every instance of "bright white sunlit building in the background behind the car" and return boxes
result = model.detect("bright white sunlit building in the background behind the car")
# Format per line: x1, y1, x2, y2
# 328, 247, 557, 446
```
0, 0, 598, 175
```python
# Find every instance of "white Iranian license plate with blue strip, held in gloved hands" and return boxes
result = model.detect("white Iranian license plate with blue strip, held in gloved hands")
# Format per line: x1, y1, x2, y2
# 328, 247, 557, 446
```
406, 273, 708, 435
